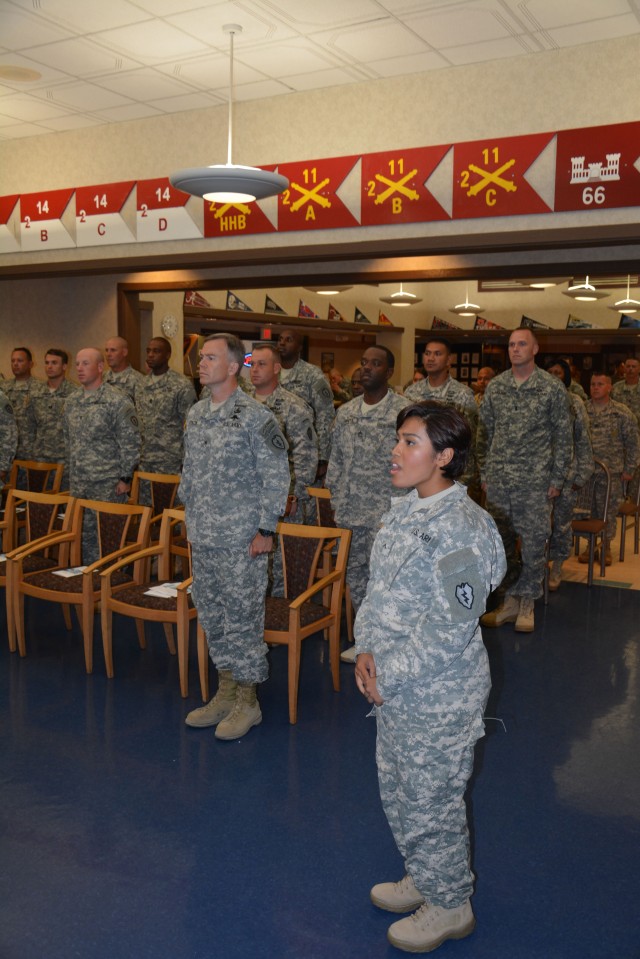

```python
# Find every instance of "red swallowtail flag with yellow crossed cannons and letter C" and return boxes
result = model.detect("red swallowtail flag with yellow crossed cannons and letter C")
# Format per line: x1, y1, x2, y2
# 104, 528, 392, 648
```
453, 133, 553, 220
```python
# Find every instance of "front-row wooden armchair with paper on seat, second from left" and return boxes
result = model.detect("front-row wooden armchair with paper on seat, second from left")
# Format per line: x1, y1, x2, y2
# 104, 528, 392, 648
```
10, 499, 151, 673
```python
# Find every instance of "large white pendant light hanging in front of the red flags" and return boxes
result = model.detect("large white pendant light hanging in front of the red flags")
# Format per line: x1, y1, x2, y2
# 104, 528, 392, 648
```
169, 23, 289, 203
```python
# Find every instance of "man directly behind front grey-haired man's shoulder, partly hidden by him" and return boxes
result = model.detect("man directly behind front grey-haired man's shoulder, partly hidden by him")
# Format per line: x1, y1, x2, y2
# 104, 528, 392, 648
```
251, 343, 318, 596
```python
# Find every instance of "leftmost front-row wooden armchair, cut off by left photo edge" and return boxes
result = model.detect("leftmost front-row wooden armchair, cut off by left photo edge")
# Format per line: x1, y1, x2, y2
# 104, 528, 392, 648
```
0, 489, 73, 653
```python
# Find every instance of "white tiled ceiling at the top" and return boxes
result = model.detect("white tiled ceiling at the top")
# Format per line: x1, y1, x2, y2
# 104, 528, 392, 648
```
0, 0, 640, 140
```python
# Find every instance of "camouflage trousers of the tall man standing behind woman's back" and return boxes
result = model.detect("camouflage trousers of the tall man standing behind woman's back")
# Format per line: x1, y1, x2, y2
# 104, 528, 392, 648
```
485, 485, 552, 600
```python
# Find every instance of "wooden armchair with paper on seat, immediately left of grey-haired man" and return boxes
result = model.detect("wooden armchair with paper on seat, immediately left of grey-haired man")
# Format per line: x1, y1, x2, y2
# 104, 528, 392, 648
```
100, 509, 196, 696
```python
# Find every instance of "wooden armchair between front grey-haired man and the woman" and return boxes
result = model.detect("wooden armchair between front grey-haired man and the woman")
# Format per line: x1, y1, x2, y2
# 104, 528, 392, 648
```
264, 523, 351, 723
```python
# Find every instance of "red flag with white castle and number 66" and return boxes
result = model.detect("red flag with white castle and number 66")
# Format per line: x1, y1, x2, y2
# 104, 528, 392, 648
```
554, 121, 640, 211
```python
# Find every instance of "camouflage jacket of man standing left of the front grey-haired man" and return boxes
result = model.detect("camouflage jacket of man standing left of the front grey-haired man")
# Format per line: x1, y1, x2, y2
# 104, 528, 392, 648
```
135, 370, 196, 473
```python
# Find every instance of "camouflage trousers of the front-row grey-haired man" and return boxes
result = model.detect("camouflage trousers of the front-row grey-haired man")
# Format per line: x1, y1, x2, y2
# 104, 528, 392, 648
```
191, 544, 269, 685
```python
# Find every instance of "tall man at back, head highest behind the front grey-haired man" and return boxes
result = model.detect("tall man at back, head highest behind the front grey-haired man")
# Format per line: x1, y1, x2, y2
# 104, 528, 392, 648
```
278, 330, 334, 479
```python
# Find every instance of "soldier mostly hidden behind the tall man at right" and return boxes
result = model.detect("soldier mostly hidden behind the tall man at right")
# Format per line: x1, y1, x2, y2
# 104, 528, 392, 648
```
546, 358, 594, 590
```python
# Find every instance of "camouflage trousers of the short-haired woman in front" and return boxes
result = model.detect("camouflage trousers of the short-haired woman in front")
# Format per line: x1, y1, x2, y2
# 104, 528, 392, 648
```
375, 703, 484, 909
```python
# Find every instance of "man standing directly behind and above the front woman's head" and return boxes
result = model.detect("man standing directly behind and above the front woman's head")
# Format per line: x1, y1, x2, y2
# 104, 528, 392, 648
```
404, 337, 478, 485
